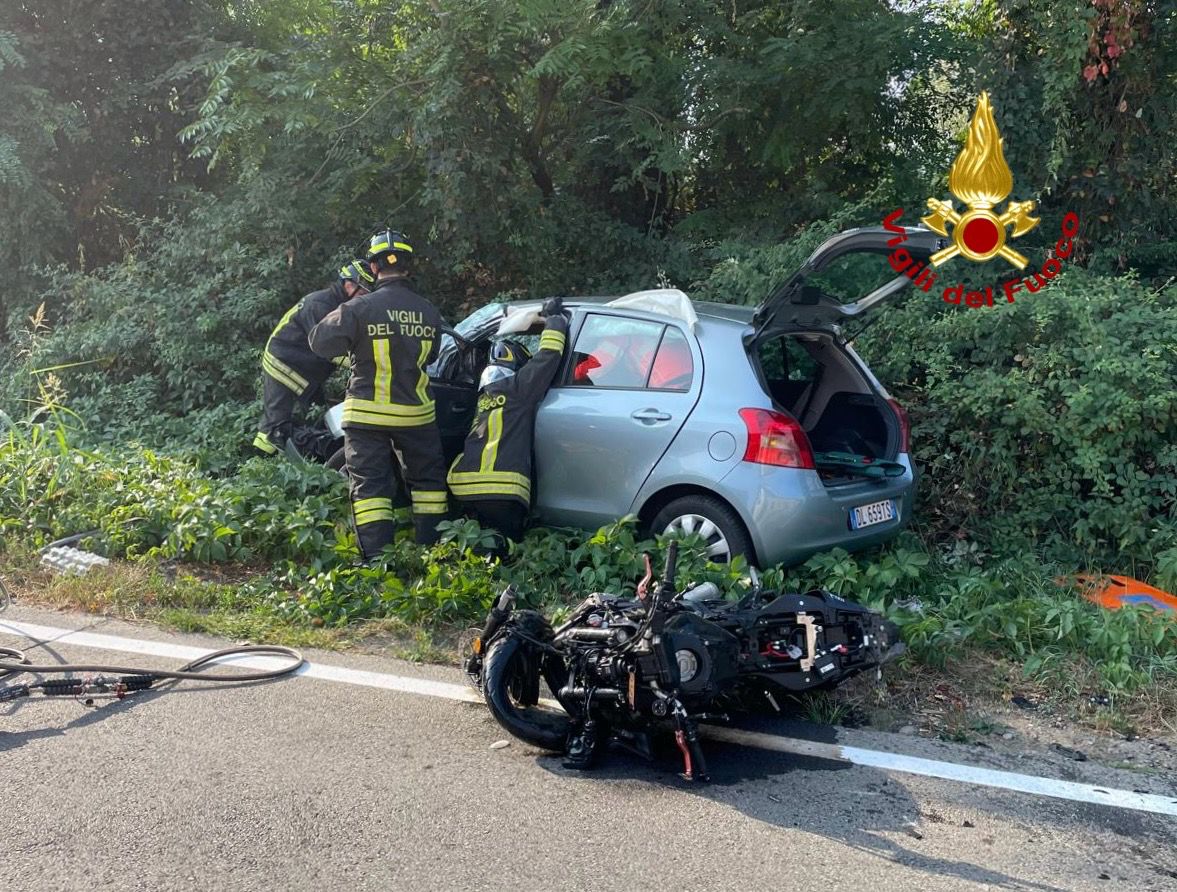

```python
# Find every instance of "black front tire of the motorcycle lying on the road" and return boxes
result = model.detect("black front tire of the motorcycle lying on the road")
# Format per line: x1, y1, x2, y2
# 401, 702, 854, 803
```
483, 631, 570, 753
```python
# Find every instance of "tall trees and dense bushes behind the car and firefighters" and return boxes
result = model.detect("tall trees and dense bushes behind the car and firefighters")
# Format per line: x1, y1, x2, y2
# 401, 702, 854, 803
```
0, 0, 1177, 571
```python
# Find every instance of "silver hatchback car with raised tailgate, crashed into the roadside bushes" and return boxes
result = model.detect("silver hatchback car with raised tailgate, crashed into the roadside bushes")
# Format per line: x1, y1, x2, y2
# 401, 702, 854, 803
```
419, 228, 943, 566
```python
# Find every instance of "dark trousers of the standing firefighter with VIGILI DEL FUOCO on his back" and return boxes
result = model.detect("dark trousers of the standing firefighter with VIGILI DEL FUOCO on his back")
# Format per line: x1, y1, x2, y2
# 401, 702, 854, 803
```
344, 424, 446, 561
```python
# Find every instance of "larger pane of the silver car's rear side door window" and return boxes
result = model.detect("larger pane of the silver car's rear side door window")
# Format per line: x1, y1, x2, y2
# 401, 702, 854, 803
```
566, 314, 666, 387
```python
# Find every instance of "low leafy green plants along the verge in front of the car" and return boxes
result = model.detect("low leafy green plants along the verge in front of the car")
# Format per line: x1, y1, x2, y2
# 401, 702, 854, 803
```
0, 427, 1177, 691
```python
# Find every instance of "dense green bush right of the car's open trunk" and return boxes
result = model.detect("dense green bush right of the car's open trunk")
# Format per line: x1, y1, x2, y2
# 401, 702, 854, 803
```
863, 271, 1177, 573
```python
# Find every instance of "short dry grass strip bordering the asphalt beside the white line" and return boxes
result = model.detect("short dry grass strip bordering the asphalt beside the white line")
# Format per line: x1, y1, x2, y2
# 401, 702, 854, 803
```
4, 544, 1177, 743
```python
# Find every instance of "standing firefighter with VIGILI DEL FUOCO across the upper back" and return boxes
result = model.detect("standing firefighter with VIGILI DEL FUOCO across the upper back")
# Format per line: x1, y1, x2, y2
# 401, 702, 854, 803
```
311, 229, 446, 564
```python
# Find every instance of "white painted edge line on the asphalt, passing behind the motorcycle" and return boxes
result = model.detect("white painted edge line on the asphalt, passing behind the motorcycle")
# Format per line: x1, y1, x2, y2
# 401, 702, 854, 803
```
0, 620, 1177, 817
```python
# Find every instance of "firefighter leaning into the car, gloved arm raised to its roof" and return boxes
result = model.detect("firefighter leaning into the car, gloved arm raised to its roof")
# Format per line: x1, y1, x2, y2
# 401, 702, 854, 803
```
448, 298, 568, 548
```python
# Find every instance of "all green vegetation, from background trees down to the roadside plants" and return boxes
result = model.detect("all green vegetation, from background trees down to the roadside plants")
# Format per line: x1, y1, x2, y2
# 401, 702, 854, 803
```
0, 0, 1177, 710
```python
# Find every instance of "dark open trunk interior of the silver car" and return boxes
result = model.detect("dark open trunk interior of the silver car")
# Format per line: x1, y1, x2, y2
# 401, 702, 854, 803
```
753, 332, 899, 485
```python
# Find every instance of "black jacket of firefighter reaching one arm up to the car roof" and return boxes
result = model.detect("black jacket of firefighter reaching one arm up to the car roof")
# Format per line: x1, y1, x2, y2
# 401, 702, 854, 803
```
448, 313, 568, 506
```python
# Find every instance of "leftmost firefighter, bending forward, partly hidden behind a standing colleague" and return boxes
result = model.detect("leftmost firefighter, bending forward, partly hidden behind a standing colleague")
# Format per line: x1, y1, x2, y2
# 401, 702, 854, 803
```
253, 260, 375, 455
